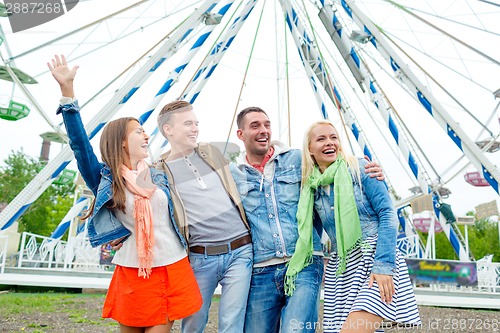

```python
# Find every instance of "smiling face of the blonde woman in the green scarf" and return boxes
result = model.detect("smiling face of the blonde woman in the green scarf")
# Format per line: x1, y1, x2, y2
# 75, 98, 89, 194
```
309, 124, 341, 170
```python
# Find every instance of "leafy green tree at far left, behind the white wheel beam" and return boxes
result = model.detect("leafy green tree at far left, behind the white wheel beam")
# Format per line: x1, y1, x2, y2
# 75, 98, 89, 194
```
0, 149, 75, 236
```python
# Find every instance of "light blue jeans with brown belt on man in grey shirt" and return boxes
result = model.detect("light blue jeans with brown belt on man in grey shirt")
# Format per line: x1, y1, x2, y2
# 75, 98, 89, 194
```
182, 244, 253, 333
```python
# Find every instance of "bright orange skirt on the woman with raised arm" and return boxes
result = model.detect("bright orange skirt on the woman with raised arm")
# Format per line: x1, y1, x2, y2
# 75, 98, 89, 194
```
102, 257, 202, 327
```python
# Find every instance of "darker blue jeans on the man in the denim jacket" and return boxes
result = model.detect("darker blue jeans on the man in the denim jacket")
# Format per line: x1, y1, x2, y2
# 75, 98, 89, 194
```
245, 256, 324, 333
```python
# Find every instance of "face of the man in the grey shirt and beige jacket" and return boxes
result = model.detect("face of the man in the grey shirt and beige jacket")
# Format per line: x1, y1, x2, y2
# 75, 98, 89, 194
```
163, 111, 198, 154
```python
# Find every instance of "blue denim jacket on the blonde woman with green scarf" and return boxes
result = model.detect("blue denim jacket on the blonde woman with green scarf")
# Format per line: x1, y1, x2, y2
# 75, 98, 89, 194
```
314, 159, 398, 275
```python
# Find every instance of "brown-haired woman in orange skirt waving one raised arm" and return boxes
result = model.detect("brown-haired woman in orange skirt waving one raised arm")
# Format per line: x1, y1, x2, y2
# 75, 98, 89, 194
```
47, 55, 202, 333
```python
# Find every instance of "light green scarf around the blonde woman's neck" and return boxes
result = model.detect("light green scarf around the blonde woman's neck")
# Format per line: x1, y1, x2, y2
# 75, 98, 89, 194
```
285, 156, 362, 296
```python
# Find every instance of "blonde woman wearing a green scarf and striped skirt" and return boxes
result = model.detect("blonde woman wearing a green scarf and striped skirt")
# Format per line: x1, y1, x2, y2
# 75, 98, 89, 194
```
286, 121, 420, 333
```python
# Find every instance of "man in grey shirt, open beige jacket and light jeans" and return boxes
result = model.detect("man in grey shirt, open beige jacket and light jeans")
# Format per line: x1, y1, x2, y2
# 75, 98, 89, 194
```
156, 101, 253, 333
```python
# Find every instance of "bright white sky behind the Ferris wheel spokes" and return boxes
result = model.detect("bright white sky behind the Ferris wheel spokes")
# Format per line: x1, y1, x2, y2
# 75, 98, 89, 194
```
0, 0, 500, 220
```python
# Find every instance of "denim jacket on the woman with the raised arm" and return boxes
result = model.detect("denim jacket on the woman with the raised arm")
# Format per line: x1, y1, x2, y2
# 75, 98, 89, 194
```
57, 101, 187, 248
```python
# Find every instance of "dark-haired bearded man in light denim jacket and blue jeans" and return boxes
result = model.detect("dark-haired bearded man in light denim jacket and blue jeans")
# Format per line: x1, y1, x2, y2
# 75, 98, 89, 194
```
231, 107, 383, 333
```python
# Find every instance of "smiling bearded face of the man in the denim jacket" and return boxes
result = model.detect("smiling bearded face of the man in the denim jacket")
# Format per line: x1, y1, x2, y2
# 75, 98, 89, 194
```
237, 112, 272, 159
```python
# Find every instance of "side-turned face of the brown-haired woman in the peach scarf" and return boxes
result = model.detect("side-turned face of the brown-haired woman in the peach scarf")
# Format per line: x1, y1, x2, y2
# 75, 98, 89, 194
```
123, 120, 149, 169
